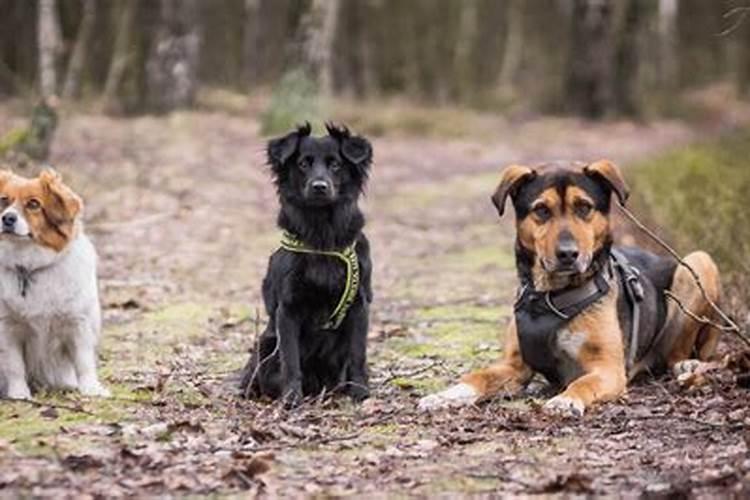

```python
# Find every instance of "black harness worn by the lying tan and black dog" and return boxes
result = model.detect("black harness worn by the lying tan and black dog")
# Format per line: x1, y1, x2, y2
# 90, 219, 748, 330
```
514, 250, 644, 384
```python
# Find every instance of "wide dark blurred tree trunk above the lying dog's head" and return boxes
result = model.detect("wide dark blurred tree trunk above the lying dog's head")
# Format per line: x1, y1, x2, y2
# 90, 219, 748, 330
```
566, 0, 613, 119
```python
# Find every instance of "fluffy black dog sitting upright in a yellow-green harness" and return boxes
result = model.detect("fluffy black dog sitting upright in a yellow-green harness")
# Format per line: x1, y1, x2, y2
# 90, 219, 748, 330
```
240, 124, 372, 406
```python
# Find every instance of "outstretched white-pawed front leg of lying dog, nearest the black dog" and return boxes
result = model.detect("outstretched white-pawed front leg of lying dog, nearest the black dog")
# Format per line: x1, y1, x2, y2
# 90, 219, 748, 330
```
419, 320, 533, 410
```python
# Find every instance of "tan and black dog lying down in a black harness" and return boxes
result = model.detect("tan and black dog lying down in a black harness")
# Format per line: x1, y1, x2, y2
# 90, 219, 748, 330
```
419, 160, 721, 415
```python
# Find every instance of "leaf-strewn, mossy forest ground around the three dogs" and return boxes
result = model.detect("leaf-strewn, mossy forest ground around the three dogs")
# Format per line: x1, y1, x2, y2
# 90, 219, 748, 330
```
0, 99, 750, 498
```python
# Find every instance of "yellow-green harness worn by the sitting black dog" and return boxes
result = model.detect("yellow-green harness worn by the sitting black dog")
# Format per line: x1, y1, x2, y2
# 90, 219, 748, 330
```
281, 231, 359, 330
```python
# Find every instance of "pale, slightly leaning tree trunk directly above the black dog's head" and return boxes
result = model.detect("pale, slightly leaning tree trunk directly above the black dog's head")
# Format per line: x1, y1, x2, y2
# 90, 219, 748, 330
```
304, 0, 339, 96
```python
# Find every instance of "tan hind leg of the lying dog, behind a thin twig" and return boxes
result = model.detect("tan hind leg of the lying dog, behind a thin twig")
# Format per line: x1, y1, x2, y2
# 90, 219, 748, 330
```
658, 252, 721, 376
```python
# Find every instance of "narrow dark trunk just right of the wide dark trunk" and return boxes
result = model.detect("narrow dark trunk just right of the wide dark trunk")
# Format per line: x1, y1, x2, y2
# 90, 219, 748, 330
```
612, 0, 647, 116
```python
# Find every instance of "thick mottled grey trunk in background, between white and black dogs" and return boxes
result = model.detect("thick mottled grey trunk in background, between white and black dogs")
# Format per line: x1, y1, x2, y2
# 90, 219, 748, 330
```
146, 0, 202, 112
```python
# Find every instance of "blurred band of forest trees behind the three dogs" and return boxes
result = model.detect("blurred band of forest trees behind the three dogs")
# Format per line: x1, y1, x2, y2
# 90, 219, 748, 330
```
0, 0, 750, 121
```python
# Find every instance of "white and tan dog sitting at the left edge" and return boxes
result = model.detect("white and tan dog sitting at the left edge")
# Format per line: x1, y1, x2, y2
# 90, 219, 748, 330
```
0, 171, 109, 399
